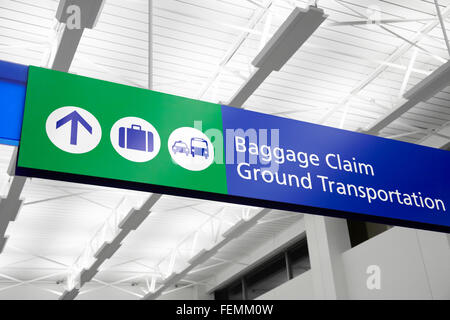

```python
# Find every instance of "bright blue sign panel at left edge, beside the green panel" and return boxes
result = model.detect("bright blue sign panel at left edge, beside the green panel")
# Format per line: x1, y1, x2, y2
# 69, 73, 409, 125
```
0, 61, 28, 146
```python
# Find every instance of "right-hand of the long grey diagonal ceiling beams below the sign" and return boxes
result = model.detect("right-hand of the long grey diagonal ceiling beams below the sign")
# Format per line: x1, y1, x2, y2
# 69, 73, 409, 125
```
142, 209, 271, 300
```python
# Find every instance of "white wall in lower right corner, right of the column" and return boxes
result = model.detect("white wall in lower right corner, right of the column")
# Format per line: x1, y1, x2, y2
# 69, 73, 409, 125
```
343, 227, 450, 299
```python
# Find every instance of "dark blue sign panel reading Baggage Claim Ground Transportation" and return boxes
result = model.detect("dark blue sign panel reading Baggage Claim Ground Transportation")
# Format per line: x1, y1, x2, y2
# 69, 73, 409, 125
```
222, 106, 450, 228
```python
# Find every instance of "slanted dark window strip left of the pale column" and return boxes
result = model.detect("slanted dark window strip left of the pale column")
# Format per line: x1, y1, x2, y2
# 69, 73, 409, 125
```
214, 238, 311, 300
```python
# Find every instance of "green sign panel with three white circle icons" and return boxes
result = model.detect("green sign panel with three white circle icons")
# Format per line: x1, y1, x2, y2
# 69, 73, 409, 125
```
17, 67, 227, 194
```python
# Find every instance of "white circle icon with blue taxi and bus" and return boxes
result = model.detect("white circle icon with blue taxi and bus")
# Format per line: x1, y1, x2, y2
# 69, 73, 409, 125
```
167, 127, 214, 171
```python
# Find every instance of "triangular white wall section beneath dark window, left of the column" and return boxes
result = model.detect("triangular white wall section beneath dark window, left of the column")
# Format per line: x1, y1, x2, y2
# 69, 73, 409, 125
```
256, 270, 315, 300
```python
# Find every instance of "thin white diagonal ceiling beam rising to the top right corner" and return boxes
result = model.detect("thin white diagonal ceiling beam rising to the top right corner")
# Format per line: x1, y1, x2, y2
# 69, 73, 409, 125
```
318, 5, 450, 124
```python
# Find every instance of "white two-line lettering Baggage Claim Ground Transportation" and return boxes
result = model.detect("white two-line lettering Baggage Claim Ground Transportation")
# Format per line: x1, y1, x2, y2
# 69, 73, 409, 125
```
234, 136, 446, 211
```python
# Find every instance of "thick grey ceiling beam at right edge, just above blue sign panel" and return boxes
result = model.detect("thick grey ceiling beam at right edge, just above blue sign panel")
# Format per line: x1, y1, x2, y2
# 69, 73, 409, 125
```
362, 61, 450, 135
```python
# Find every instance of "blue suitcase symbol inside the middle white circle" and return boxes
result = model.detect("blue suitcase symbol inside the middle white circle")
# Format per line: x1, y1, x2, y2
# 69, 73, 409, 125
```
119, 124, 153, 152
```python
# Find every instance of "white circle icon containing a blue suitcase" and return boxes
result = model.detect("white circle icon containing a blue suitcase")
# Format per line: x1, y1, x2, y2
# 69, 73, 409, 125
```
110, 117, 161, 162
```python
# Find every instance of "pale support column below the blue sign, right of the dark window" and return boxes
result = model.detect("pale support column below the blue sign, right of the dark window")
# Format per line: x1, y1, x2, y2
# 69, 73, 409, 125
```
305, 214, 351, 300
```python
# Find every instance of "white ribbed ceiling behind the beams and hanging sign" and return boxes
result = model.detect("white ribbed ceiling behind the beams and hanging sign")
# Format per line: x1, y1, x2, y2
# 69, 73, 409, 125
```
0, 0, 450, 299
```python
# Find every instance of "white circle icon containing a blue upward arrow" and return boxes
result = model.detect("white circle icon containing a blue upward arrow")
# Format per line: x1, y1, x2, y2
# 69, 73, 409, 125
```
45, 107, 102, 153
